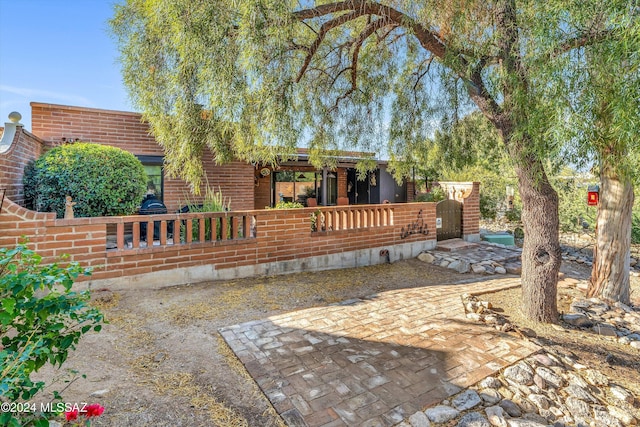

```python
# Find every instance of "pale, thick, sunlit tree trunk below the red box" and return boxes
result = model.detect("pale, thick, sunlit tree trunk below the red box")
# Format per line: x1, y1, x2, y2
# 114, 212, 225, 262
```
587, 165, 634, 304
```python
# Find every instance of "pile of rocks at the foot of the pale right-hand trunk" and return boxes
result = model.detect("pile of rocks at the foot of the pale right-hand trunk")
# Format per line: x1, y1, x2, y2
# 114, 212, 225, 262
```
562, 298, 640, 349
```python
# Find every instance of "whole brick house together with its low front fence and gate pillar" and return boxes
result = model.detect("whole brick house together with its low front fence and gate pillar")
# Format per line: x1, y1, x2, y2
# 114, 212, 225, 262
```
0, 103, 480, 289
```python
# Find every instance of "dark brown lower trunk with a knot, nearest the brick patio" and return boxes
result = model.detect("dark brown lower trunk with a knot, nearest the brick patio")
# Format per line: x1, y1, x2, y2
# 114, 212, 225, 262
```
516, 152, 562, 323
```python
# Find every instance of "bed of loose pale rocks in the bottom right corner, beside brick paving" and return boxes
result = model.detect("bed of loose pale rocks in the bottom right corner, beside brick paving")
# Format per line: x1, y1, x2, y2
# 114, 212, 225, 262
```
396, 352, 638, 427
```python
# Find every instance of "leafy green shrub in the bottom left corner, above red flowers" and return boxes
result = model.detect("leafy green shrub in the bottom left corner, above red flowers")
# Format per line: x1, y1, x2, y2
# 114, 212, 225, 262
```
0, 245, 103, 425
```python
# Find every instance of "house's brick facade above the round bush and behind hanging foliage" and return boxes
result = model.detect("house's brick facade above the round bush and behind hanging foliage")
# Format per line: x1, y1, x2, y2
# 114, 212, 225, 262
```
31, 102, 254, 212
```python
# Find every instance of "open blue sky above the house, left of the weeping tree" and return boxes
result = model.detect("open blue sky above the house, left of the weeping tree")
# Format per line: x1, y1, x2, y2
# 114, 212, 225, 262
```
0, 0, 133, 130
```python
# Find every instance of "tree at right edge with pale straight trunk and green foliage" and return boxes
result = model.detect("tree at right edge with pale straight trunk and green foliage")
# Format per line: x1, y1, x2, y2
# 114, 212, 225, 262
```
554, 1, 640, 303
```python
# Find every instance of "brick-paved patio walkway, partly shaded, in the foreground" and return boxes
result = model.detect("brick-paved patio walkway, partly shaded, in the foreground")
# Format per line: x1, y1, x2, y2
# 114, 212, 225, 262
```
220, 278, 538, 426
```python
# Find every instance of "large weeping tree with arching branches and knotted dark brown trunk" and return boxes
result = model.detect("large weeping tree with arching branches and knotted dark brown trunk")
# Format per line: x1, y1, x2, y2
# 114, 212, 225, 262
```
111, 0, 632, 322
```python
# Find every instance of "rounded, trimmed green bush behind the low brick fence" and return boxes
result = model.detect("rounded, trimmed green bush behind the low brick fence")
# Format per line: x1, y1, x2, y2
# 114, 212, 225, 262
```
24, 143, 147, 218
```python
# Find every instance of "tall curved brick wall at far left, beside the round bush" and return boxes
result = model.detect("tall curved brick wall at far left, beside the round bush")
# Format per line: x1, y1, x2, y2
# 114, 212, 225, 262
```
0, 126, 44, 206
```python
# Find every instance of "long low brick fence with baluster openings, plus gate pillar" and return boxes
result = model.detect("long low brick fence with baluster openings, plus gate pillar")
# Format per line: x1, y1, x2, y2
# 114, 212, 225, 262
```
0, 185, 478, 287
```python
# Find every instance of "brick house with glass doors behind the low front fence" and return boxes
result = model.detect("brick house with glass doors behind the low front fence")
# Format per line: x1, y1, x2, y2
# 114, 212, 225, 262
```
0, 102, 413, 211
